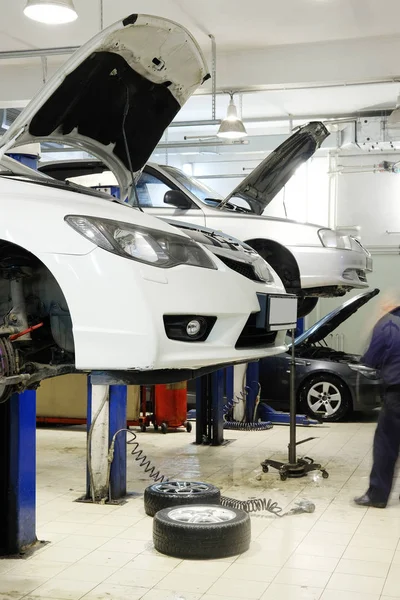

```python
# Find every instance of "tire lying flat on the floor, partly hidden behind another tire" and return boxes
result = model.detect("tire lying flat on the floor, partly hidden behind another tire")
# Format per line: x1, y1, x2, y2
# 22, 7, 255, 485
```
144, 481, 221, 517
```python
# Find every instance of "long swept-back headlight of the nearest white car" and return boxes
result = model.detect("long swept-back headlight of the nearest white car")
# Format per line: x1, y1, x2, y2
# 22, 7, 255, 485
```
65, 215, 217, 269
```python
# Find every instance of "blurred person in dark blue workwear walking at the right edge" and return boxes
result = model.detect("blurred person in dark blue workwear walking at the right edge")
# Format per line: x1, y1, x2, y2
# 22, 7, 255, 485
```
355, 303, 400, 508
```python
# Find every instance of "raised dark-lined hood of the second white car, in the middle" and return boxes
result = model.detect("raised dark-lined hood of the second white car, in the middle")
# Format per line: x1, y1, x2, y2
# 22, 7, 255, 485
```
219, 121, 329, 215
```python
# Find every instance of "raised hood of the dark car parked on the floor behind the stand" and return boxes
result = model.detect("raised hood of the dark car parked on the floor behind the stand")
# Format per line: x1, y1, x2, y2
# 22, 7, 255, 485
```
294, 289, 380, 346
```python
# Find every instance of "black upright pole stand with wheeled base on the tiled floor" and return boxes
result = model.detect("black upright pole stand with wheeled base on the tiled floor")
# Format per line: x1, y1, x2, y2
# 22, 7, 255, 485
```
261, 329, 329, 481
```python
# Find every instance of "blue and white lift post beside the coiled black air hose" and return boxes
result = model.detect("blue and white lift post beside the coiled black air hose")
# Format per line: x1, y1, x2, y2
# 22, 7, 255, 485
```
83, 373, 127, 502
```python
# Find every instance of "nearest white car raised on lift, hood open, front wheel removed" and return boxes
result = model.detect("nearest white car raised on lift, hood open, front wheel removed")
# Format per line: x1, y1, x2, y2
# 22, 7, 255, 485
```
0, 15, 296, 401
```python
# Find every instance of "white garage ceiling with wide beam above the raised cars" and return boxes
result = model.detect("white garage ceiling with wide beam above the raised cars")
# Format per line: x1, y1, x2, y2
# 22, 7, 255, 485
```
0, 0, 400, 162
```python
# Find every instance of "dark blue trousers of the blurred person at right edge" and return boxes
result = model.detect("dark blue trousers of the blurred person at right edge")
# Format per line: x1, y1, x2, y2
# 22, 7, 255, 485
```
368, 385, 400, 502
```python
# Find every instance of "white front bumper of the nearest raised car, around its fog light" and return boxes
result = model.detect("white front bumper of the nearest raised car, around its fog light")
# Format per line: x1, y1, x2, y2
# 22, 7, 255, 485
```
40, 248, 292, 372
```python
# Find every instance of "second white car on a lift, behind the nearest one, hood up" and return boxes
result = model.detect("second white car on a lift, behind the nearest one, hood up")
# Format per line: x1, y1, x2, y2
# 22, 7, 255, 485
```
41, 122, 372, 317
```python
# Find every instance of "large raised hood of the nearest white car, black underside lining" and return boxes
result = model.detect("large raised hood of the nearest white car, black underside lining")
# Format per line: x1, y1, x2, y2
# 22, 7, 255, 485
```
0, 14, 209, 200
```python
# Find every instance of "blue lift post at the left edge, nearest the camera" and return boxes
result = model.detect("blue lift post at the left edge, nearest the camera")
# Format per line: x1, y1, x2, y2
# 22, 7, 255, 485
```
0, 390, 37, 556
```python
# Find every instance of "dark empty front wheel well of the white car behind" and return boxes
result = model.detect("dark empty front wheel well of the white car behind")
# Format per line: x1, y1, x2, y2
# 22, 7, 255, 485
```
246, 239, 301, 293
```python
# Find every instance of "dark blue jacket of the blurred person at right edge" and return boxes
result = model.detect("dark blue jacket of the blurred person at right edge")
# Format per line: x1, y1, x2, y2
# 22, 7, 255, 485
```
360, 306, 400, 386
